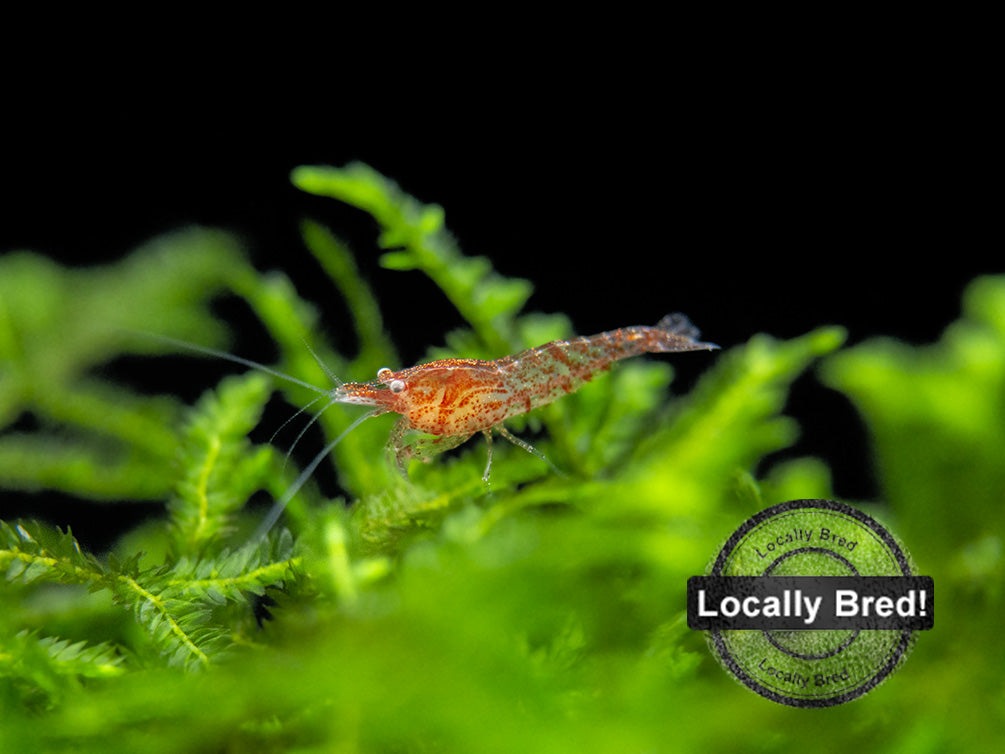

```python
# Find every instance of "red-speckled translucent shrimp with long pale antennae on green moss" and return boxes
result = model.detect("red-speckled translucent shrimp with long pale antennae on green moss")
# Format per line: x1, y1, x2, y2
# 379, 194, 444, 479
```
154, 314, 719, 530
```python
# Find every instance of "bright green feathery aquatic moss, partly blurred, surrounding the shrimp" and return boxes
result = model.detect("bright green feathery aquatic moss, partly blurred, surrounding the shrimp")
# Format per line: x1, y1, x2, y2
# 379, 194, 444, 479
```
0, 164, 1005, 752
